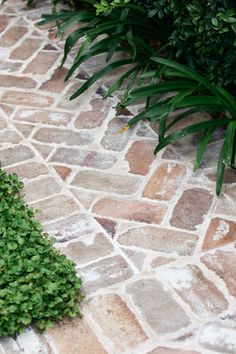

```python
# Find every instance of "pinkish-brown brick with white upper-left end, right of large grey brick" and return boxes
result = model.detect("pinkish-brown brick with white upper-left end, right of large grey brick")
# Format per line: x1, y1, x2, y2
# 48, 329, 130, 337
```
164, 265, 228, 318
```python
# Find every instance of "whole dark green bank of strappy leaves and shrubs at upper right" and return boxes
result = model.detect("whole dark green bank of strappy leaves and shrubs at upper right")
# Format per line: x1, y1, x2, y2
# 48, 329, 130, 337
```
39, 0, 236, 194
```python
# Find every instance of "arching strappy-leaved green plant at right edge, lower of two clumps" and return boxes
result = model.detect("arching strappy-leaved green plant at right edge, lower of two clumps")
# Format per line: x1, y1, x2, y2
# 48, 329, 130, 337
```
120, 57, 236, 195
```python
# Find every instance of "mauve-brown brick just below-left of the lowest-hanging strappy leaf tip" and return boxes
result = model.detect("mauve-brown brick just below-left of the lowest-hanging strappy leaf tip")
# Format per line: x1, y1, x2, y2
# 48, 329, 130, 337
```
170, 188, 213, 230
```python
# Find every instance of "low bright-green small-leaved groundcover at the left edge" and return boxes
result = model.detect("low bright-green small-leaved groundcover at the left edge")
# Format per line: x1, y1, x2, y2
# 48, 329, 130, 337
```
0, 169, 82, 336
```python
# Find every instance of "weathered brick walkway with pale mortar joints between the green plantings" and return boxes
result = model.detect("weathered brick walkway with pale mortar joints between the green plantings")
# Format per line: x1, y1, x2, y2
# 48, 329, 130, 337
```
0, 0, 236, 354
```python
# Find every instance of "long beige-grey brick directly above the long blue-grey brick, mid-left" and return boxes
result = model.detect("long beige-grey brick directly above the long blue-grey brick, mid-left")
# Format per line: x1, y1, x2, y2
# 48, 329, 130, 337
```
33, 128, 93, 146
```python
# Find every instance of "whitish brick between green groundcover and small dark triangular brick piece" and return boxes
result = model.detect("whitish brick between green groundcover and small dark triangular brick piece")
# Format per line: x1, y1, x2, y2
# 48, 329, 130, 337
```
44, 214, 98, 242
